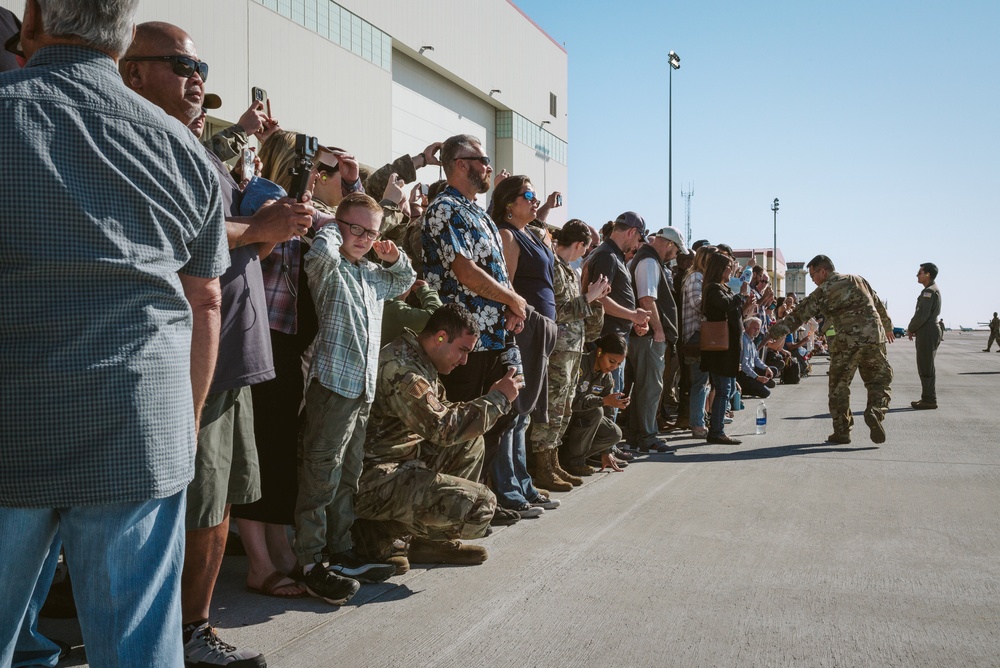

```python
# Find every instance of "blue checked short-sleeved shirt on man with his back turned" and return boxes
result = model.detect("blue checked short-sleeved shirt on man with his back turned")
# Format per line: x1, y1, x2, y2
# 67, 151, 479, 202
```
0, 46, 229, 506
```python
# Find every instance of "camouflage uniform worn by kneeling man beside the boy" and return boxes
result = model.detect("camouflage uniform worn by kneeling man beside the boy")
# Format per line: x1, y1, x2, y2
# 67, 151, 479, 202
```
354, 330, 510, 553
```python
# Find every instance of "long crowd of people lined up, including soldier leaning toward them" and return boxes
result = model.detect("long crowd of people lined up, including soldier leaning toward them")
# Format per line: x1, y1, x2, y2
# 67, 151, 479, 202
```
0, 0, 908, 668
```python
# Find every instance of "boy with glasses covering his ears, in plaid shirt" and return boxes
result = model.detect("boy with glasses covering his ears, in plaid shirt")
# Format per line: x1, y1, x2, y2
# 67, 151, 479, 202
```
295, 193, 416, 605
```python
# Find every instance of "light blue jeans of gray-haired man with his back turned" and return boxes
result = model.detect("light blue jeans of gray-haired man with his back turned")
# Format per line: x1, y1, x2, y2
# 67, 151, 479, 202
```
0, 491, 185, 668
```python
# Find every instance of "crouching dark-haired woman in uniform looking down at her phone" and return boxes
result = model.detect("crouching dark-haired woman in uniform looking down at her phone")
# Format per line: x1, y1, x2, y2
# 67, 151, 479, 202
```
559, 333, 629, 476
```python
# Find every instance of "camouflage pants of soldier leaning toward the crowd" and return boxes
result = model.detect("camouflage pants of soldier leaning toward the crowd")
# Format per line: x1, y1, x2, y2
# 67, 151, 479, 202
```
830, 343, 892, 435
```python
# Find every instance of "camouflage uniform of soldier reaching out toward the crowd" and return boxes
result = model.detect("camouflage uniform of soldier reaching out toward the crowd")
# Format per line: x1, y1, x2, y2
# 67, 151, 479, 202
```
767, 272, 892, 436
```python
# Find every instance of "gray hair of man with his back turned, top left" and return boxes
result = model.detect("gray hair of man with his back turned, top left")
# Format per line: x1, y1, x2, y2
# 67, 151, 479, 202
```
38, 0, 139, 57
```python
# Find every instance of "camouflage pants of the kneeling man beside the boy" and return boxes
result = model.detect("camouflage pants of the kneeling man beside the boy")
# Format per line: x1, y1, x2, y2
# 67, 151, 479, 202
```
354, 436, 497, 541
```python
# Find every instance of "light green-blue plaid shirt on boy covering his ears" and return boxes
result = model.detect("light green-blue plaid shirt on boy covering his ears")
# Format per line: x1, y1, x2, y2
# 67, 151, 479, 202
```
305, 223, 417, 403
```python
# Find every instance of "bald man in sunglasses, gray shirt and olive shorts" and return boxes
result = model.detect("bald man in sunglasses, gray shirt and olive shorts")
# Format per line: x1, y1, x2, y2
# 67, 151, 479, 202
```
121, 22, 314, 668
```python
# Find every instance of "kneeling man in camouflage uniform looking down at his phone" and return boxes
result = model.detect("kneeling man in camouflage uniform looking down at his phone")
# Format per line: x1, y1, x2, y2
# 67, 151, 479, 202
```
353, 304, 520, 572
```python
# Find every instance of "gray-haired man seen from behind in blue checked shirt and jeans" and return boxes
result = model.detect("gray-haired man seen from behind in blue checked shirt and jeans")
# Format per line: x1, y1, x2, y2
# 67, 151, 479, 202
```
0, 0, 229, 666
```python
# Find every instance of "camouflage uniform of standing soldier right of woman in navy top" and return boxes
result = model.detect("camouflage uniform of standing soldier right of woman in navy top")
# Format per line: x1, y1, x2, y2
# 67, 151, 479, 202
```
529, 253, 604, 452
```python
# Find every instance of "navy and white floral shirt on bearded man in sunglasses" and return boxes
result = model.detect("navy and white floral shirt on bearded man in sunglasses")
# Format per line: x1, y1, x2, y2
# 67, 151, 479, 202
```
421, 186, 510, 352
